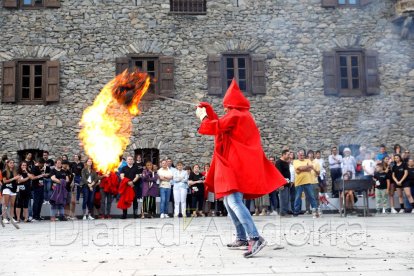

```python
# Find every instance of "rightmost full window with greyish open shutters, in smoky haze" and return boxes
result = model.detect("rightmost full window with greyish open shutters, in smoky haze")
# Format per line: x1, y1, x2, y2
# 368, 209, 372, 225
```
323, 49, 380, 97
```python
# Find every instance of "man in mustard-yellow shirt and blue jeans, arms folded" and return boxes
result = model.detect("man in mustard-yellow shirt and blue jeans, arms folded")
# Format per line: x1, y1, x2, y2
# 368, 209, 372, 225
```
293, 150, 319, 218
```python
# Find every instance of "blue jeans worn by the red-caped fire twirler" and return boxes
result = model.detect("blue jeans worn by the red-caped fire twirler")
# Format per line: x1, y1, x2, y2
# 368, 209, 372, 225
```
224, 192, 259, 241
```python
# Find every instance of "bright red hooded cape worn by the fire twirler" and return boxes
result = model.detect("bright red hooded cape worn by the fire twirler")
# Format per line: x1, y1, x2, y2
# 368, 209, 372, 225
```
198, 80, 286, 199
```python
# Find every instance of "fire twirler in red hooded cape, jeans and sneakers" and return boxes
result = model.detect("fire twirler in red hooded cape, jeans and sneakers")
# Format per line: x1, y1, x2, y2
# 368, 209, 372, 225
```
196, 80, 286, 258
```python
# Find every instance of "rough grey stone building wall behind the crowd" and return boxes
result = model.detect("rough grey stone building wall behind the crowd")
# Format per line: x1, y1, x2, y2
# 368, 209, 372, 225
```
0, 0, 414, 169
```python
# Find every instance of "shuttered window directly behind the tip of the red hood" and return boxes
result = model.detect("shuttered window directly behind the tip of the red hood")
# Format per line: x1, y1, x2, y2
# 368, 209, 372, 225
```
208, 53, 266, 96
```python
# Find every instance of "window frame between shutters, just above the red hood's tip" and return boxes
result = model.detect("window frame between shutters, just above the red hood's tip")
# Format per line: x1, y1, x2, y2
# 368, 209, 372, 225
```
221, 52, 253, 95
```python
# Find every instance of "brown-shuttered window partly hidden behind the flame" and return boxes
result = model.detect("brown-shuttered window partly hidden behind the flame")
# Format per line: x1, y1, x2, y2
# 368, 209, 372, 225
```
116, 55, 174, 97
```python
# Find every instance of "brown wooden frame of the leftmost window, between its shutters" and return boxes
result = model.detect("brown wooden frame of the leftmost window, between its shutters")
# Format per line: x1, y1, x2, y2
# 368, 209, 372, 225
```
16, 59, 48, 105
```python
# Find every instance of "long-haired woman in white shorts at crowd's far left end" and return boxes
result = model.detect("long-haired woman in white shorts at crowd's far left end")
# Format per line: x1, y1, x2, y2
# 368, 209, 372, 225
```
1, 159, 20, 223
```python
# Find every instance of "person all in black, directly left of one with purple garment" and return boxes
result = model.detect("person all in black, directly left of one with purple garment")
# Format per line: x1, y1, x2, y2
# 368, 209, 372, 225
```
32, 158, 50, 221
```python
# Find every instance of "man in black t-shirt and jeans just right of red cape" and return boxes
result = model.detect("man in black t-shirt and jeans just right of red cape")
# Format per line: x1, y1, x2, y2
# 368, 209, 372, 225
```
276, 149, 292, 217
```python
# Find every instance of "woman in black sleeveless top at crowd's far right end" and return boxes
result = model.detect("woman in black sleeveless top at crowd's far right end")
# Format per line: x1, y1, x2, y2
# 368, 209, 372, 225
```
392, 154, 414, 213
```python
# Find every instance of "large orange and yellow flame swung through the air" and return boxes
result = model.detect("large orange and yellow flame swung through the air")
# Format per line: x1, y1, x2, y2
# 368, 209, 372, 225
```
79, 70, 150, 173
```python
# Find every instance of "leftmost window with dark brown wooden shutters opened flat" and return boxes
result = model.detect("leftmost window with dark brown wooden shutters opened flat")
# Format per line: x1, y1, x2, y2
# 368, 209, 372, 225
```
2, 60, 60, 104
